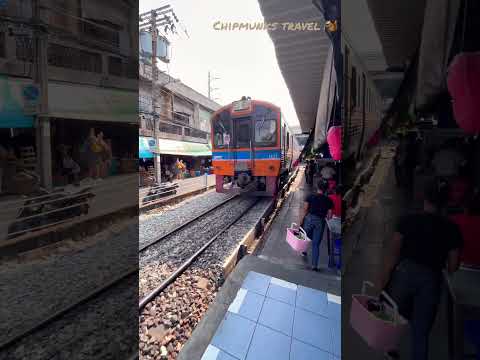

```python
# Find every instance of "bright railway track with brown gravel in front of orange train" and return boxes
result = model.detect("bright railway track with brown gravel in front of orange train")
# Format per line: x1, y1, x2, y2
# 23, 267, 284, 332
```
138, 172, 297, 360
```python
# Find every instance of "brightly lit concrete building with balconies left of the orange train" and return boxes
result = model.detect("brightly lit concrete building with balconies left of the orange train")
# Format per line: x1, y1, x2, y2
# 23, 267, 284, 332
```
139, 59, 221, 183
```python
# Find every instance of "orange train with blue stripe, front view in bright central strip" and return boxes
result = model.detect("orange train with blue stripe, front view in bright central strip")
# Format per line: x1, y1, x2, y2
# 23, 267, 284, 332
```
211, 96, 302, 197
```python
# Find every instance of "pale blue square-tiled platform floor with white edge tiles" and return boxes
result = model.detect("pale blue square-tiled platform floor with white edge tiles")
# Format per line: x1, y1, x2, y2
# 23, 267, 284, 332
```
202, 271, 341, 360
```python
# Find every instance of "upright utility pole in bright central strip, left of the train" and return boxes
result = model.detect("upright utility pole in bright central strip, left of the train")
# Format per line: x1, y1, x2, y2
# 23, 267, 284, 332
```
150, 10, 162, 185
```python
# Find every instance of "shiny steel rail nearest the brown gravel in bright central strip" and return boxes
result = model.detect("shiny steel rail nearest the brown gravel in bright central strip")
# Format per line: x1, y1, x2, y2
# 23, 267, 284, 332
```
138, 199, 259, 311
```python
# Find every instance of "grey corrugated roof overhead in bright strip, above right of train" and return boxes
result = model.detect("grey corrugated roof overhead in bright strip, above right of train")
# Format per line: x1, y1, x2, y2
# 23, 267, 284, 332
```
259, 0, 330, 131
